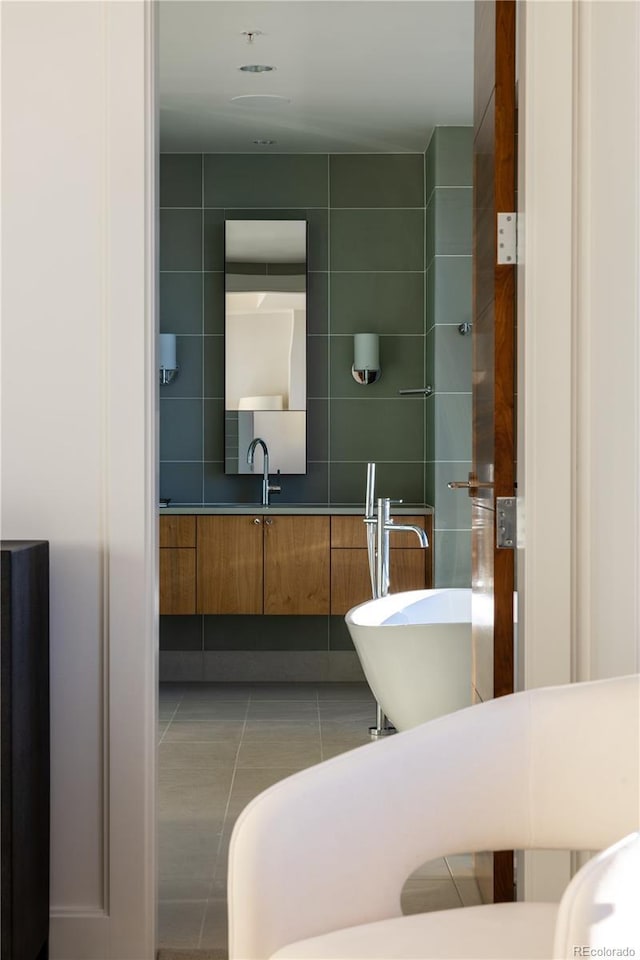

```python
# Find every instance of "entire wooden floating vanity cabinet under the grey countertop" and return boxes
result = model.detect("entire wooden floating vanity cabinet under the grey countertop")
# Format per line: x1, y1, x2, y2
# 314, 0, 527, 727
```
160, 514, 433, 615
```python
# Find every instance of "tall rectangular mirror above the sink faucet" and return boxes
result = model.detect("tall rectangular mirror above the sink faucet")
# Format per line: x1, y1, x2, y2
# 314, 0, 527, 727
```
225, 220, 307, 474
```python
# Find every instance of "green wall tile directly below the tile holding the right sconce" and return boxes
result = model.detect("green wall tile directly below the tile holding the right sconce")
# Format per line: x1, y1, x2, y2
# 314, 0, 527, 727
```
329, 397, 424, 462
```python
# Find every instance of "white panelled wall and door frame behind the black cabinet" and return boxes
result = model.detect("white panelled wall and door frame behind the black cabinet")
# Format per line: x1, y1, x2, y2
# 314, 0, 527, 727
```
1, 0, 157, 960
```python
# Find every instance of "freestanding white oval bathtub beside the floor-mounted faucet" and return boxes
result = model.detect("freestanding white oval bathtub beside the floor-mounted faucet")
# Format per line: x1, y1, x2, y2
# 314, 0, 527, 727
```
345, 588, 471, 730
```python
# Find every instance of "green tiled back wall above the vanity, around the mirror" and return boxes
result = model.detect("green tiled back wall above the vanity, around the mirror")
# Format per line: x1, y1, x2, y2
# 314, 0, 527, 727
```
160, 154, 430, 504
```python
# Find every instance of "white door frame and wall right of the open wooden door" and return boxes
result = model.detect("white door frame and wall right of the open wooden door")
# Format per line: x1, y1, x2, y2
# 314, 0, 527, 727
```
518, 0, 640, 899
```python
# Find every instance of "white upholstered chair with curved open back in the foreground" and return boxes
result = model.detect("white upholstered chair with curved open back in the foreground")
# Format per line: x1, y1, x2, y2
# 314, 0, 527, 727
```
228, 676, 640, 960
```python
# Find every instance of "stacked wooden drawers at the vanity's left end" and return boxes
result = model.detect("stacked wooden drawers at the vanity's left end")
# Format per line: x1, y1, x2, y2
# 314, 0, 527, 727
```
160, 515, 196, 615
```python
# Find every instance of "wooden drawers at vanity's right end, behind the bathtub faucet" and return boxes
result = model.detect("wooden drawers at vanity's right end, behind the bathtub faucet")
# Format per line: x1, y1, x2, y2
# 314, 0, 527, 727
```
331, 516, 433, 615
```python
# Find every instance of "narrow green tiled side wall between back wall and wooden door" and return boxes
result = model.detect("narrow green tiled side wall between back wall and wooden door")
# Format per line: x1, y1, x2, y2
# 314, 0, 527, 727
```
425, 127, 473, 587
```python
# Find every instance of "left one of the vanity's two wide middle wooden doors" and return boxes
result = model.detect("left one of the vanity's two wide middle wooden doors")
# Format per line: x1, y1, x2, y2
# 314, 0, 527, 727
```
197, 515, 263, 613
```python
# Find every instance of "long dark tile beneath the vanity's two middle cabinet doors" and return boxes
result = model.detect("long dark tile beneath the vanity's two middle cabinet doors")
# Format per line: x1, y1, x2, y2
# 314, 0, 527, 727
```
204, 615, 328, 650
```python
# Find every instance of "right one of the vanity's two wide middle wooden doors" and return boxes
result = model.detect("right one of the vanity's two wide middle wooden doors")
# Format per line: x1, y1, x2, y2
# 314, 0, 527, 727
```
264, 516, 330, 614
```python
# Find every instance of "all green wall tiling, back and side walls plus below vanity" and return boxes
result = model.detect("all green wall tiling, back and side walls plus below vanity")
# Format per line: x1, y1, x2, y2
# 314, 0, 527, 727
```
160, 146, 471, 672
